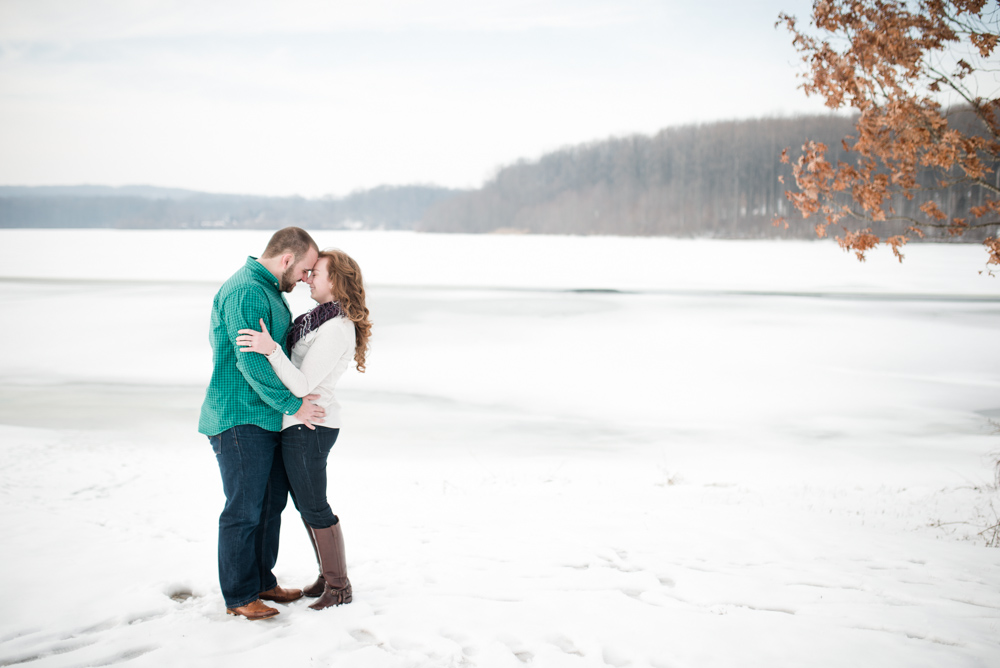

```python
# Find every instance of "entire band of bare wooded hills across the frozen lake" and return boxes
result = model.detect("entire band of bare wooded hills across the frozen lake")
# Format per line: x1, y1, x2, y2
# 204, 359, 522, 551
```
0, 115, 1000, 241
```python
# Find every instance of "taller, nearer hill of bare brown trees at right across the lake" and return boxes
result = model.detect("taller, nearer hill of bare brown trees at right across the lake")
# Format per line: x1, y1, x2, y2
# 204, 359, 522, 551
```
418, 115, 1000, 241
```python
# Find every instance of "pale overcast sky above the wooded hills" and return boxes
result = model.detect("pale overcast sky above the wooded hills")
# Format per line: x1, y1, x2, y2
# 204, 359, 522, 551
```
0, 0, 825, 197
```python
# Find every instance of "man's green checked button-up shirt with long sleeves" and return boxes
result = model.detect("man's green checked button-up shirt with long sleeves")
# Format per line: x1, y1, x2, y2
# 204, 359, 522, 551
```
198, 257, 302, 436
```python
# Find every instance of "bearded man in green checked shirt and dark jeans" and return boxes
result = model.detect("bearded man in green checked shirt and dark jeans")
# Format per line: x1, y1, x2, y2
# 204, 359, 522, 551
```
198, 227, 325, 619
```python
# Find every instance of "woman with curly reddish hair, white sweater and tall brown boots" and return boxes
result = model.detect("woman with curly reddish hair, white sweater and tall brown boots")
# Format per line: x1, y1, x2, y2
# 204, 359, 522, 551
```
236, 250, 372, 610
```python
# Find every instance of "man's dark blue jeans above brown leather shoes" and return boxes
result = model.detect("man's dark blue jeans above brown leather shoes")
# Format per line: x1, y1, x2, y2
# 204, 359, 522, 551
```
208, 424, 288, 608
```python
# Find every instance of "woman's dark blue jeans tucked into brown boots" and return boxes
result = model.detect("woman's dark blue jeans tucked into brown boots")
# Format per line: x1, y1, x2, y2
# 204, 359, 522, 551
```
281, 424, 340, 529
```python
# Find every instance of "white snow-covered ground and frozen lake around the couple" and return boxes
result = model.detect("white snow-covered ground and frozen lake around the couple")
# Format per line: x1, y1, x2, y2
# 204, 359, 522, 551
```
0, 230, 1000, 668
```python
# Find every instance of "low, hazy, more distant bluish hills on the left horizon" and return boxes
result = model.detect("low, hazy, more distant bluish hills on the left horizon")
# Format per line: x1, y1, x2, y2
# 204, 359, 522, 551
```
0, 186, 463, 230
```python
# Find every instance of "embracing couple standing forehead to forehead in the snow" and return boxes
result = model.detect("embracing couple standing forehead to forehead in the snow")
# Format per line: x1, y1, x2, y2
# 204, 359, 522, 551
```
198, 227, 371, 619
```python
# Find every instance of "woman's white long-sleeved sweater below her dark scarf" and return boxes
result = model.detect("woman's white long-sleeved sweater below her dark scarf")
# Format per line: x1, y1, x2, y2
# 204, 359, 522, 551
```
267, 315, 354, 429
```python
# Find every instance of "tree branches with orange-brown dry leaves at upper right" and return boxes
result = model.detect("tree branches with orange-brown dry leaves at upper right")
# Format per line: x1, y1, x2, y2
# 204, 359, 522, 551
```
775, 0, 1000, 264
